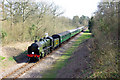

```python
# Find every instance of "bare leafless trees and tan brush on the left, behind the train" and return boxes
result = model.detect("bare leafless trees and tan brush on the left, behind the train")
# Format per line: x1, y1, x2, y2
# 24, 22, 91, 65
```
0, 0, 89, 44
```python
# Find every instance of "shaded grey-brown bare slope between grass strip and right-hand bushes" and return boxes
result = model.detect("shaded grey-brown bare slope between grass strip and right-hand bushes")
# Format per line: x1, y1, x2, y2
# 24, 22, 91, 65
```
57, 39, 94, 78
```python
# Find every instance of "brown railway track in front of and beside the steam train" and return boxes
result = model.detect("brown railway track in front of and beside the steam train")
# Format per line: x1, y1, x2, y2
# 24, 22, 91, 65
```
1, 30, 85, 80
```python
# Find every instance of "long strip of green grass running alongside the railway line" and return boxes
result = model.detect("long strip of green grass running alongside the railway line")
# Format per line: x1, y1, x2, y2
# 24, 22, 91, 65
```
43, 30, 91, 78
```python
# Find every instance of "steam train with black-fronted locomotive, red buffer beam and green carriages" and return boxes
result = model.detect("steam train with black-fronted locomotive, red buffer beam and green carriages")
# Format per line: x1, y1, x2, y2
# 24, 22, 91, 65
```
27, 26, 85, 61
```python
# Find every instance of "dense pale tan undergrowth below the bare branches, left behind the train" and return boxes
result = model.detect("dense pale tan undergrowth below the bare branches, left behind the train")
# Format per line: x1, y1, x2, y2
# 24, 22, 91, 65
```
2, 17, 74, 45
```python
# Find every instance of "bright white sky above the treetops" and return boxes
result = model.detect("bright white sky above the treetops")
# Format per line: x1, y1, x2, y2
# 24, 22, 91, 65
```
36, 0, 101, 19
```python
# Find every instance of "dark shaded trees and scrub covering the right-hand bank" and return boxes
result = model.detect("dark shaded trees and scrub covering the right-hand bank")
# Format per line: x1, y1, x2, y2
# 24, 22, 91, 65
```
89, 1, 120, 78
